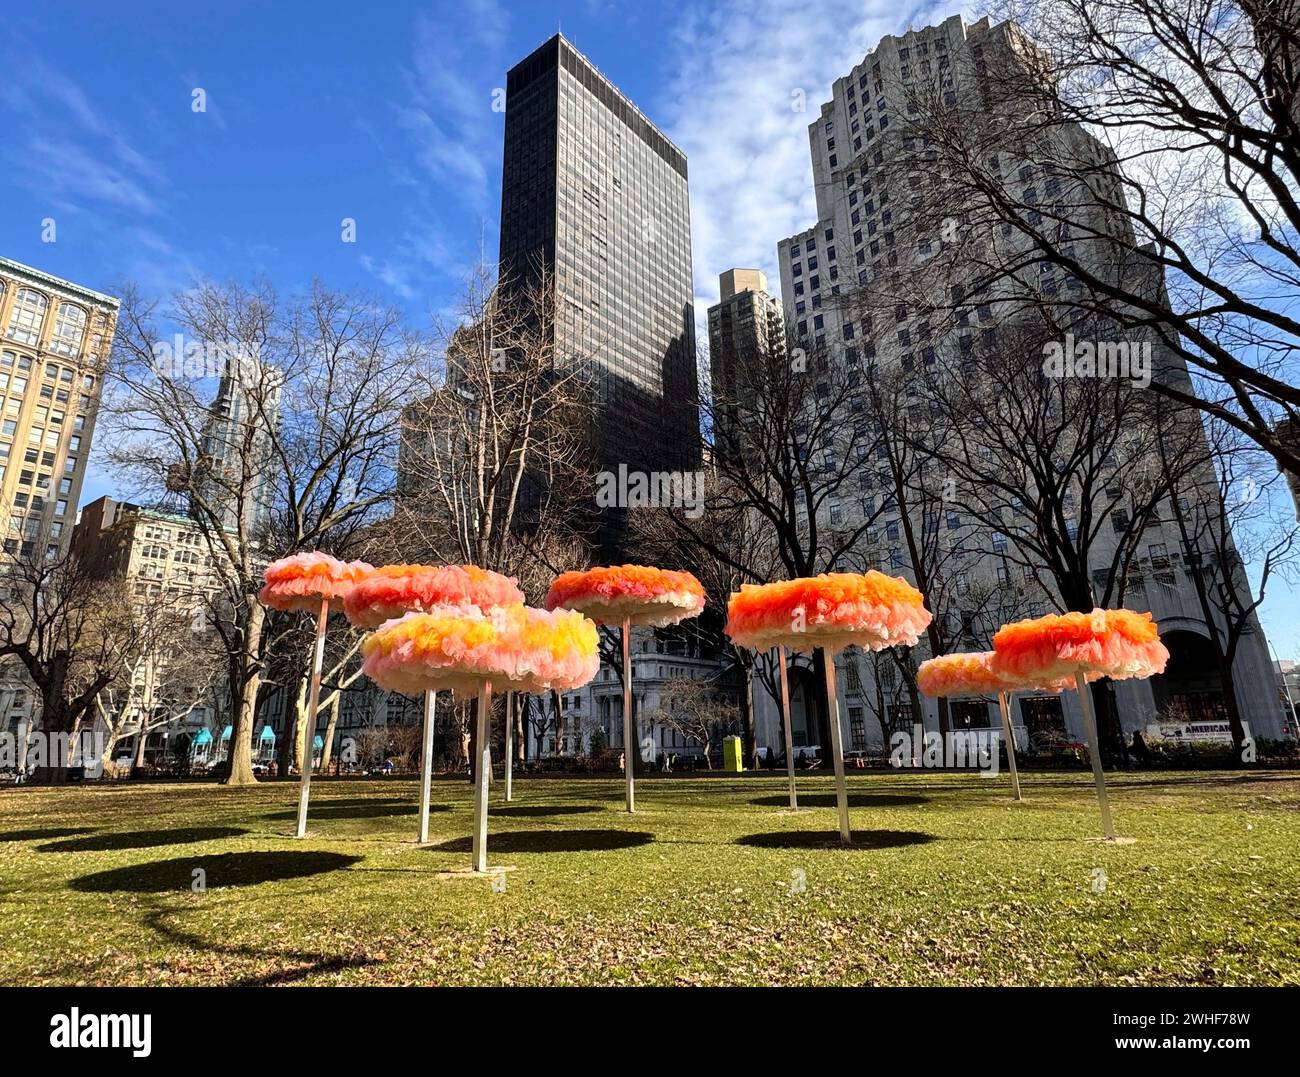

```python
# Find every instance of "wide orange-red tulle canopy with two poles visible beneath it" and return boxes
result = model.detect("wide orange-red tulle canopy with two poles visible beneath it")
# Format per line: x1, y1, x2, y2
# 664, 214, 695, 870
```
727, 571, 930, 652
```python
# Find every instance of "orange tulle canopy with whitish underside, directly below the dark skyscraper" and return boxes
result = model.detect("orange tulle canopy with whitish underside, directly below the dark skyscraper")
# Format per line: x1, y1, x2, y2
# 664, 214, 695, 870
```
543, 565, 705, 628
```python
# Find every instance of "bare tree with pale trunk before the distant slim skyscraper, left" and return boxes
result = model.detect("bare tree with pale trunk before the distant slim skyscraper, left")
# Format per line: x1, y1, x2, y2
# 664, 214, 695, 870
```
104, 282, 426, 784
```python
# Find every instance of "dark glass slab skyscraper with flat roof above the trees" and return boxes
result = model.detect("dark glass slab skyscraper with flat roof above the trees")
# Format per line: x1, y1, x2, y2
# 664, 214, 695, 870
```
501, 34, 699, 471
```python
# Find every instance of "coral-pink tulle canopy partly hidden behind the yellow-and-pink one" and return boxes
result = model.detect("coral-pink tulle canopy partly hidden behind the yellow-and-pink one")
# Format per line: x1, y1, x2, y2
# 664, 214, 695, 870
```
343, 565, 524, 628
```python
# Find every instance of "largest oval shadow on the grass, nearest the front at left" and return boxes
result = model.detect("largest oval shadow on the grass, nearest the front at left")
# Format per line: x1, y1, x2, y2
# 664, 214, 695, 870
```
68, 852, 361, 894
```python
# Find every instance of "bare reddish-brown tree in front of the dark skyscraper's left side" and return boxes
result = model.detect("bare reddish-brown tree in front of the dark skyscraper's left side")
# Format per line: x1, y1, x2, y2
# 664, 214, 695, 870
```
391, 267, 594, 601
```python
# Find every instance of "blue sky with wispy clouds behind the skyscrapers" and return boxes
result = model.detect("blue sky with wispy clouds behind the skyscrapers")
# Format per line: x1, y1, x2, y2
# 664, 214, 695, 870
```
0, 0, 1300, 658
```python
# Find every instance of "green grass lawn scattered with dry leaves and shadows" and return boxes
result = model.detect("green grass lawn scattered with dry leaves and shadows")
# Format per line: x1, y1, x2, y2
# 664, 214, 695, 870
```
0, 773, 1300, 985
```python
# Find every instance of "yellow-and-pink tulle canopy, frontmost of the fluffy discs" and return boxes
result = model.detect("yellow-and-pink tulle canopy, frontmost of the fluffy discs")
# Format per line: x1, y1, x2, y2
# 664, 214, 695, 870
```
361, 606, 601, 695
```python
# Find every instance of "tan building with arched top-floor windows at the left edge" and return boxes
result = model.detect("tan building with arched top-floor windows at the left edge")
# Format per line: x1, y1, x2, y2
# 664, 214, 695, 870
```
0, 258, 118, 557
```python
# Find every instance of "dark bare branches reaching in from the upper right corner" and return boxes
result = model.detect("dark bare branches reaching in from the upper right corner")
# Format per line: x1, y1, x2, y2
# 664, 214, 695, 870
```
909, 0, 1300, 472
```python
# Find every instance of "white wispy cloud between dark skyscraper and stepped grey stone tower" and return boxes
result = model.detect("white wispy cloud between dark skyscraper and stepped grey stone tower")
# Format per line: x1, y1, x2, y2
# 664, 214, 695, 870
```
659, 0, 965, 310
